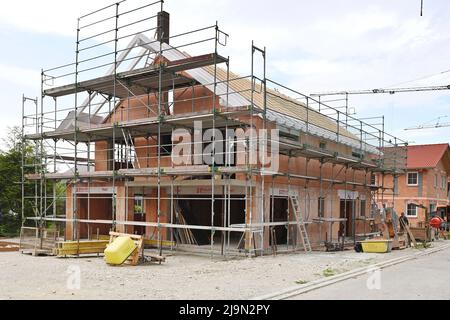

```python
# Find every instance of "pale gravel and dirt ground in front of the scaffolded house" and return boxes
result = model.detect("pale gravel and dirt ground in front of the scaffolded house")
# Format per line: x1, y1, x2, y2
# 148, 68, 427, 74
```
0, 239, 442, 300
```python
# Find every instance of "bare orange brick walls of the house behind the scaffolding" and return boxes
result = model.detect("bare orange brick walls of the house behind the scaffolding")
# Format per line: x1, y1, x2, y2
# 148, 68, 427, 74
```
66, 87, 371, 248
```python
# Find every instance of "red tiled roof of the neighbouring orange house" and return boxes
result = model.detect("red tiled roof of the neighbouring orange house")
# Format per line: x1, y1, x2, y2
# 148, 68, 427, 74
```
407, 143, 449, 169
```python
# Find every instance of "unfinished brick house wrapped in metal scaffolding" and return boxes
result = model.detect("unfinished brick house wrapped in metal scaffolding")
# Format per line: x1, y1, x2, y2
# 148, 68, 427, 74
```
23, 1, 406, 256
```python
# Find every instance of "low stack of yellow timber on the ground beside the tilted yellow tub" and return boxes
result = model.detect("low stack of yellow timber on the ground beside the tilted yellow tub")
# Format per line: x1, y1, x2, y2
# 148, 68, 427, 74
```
53, 240, 109, 257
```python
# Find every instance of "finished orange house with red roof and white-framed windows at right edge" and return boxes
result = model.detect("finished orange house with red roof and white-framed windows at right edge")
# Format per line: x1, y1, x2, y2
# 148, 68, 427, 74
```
376, 143, 450, 226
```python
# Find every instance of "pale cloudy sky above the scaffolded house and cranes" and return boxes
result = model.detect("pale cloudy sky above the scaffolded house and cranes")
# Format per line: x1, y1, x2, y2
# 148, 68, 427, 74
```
0, 0, 450, 148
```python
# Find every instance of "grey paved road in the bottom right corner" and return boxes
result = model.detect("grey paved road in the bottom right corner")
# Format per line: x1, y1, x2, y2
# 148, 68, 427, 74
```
290, 248, 450, 300
